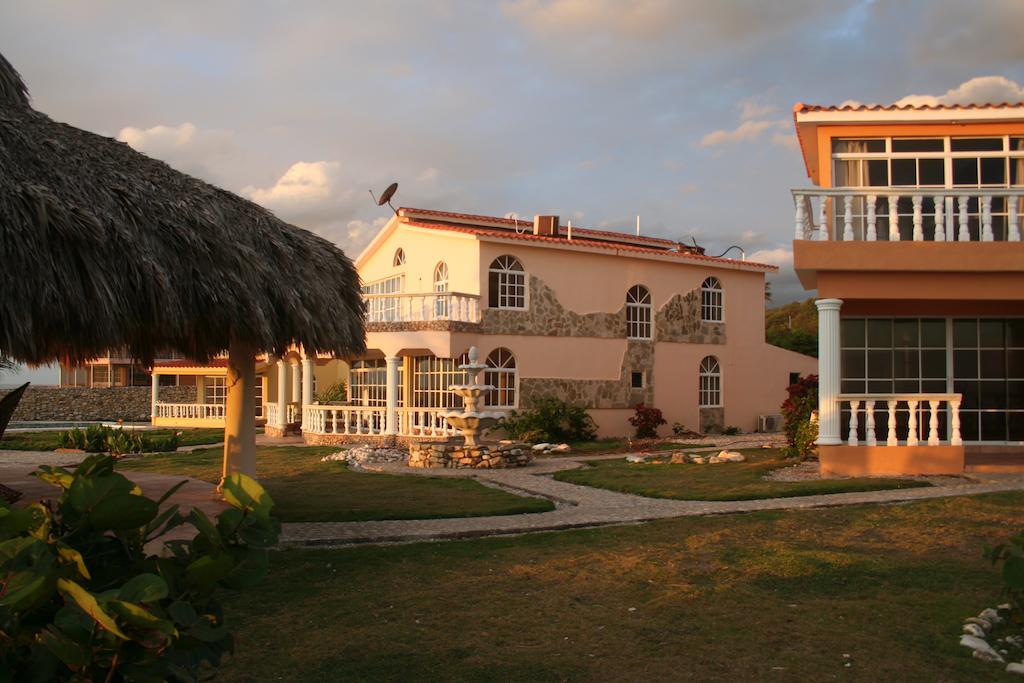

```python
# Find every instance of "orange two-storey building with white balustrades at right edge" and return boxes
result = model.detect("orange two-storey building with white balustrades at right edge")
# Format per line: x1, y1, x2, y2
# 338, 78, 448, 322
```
793, 103, 1024, 474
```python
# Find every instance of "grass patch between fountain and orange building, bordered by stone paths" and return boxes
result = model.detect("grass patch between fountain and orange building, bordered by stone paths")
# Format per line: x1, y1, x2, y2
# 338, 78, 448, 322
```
555, 450, 929, 501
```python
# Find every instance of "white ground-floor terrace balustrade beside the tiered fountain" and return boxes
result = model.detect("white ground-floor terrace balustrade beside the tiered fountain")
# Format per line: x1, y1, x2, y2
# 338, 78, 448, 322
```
302, 405, 459, 437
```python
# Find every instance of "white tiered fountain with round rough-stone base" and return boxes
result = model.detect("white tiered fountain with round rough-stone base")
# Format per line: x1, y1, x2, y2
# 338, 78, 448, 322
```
409, 346, 531, 468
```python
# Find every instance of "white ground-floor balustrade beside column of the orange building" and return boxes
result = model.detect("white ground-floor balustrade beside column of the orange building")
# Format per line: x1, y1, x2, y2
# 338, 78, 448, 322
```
837, 393, 964, 445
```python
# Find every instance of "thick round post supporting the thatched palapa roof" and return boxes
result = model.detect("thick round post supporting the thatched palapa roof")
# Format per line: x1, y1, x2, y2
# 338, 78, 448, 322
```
218, 339, 256, 490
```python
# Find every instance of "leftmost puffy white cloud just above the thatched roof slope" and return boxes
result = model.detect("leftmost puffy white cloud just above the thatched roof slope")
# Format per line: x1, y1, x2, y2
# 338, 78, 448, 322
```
118, 121, 238, 184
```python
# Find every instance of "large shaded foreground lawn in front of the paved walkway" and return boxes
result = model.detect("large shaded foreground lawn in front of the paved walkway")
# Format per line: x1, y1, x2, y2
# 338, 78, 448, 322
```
211, 493, 1024, 683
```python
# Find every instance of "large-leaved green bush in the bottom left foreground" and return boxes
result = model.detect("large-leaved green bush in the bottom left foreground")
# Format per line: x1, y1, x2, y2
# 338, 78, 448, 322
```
0, 456, 280, 681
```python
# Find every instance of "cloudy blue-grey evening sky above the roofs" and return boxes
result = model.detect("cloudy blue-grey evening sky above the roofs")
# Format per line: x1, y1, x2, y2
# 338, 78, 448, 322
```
0, 0, 1024, 381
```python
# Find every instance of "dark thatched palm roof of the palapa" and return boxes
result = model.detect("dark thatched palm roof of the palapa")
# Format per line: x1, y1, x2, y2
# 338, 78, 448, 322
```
0, 55, 365, 362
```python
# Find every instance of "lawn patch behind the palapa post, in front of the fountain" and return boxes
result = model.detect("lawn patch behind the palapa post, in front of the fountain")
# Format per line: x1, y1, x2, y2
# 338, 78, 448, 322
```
118, 446, 554, 522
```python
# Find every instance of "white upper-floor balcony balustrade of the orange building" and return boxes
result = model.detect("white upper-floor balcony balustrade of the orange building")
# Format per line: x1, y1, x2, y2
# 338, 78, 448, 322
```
792, 187, 1024, 242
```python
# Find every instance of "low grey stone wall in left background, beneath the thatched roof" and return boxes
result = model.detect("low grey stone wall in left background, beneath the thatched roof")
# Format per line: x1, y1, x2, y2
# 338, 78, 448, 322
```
12, 386, 196, 422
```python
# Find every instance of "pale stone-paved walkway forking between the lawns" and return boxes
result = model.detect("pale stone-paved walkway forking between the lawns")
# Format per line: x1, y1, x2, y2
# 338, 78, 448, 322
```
282, 454, 1024, 547
